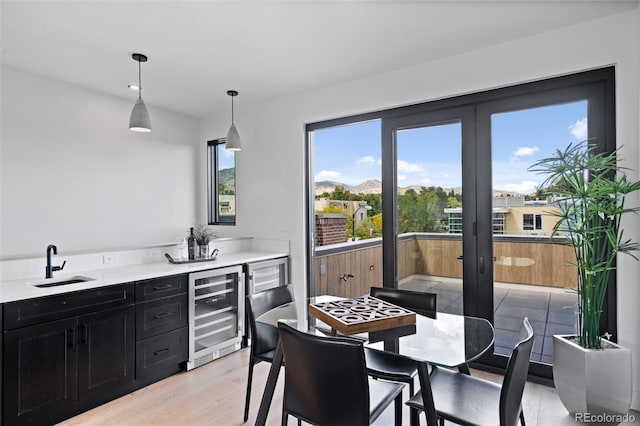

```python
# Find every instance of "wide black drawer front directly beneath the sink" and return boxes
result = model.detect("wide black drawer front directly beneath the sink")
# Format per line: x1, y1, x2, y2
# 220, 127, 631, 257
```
4, 283, 134, 330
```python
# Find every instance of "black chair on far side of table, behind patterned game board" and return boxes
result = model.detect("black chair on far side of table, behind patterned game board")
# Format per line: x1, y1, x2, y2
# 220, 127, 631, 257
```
365, 287, 436, 421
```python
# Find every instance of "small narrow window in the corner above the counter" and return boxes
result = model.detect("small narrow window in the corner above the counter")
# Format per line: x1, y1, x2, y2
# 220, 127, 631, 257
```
207, 139, 236, 225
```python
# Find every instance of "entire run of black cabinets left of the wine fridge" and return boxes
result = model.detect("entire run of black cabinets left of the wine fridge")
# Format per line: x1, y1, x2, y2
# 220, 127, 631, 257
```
0, 274, 189, 426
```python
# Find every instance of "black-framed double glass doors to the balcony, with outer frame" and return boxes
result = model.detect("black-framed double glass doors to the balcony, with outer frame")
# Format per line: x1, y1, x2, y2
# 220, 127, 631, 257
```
307, 68, 616, 379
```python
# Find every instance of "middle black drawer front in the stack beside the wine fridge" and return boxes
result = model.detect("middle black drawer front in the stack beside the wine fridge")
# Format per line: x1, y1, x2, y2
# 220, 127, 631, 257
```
136, 293, 189, 340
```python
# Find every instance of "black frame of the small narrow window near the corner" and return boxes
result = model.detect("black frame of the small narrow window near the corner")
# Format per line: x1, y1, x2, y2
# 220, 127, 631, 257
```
207, 138, 237, 226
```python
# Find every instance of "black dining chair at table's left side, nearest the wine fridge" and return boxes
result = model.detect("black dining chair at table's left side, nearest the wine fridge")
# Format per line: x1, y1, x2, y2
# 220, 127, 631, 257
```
244, 285, 293, 422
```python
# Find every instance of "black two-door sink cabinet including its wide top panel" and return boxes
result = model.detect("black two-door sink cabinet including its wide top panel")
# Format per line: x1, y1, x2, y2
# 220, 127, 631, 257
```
2, 284, 135, 425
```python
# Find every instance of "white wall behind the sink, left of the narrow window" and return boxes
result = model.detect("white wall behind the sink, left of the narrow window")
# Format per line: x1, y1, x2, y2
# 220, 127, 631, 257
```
0, 67, 199, 257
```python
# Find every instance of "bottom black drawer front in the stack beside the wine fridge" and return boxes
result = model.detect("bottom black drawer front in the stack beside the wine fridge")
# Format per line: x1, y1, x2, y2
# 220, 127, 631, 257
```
136, 327, 189, 379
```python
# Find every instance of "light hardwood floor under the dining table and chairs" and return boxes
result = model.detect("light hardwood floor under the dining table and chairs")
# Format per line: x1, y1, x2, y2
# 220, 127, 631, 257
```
61, 349, 640, 426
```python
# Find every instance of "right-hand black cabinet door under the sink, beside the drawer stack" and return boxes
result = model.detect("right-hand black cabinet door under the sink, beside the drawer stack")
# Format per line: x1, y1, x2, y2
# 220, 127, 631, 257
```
78, 306, 135, 407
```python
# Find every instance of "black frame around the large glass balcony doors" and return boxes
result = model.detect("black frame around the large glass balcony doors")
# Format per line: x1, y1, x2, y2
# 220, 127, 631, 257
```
304, 66, 618, 383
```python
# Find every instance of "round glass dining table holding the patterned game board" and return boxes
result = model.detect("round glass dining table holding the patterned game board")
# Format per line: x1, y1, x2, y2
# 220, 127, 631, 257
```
256, 296, 494, 426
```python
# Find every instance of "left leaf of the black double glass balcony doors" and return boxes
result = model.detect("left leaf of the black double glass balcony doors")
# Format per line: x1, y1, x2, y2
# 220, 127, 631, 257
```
382, 107, 476, 314
